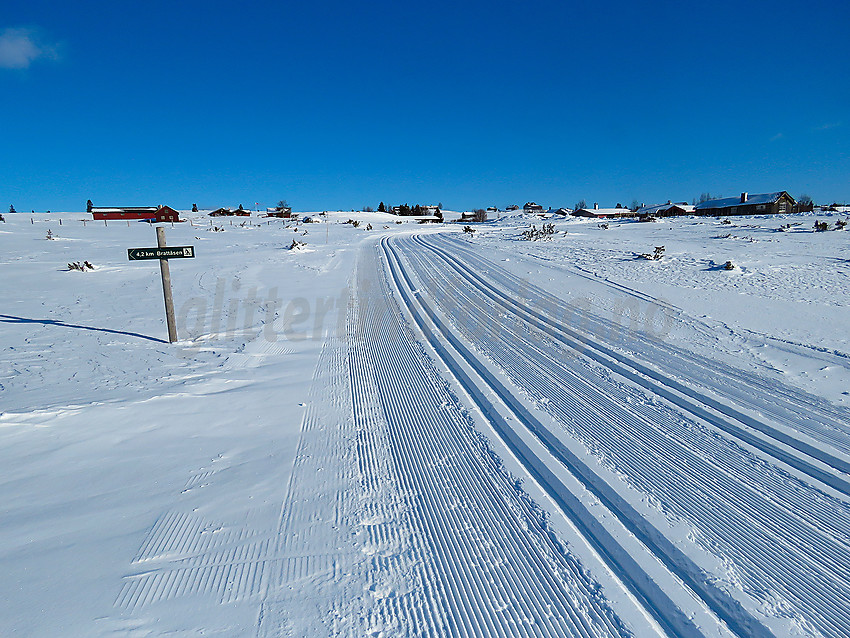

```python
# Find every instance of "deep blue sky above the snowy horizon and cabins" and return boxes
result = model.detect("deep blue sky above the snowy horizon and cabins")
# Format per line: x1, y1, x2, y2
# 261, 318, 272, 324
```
0, 0, 850, 211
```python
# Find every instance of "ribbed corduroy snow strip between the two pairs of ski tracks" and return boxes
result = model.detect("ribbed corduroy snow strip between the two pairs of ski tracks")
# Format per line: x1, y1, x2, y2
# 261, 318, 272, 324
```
388, 235, 850, 636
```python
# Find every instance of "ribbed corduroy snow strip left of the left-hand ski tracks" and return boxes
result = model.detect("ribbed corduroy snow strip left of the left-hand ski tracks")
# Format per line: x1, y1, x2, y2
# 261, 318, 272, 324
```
352, 247, 629, 638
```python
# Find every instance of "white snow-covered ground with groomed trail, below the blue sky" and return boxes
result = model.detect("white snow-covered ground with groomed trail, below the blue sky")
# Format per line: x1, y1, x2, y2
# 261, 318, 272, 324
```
0, 212, 850, 637
